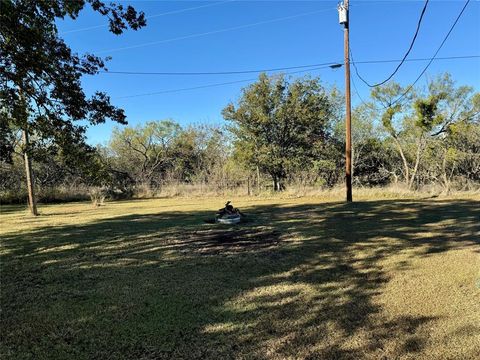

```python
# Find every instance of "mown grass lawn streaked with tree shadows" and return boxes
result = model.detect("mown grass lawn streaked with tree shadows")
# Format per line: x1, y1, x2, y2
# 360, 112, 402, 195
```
0, 196, 480, 359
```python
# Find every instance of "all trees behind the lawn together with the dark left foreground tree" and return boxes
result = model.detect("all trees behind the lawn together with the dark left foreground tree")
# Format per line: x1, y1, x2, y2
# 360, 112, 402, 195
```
0, 0, 480, 215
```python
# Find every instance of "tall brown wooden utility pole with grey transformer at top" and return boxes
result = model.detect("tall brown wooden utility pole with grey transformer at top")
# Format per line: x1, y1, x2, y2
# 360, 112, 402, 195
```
338, 0, 352, 202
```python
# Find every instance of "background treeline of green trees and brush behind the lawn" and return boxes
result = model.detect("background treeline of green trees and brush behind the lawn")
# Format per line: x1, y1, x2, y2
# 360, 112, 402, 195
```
0, 74, 480, 203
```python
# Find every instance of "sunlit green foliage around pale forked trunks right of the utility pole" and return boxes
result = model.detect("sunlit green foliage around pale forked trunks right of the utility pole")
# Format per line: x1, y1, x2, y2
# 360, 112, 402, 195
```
372, 74, 480, 189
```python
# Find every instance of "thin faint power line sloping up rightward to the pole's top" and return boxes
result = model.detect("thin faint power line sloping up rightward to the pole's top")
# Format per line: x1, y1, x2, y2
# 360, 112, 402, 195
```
95, 8, 335, 54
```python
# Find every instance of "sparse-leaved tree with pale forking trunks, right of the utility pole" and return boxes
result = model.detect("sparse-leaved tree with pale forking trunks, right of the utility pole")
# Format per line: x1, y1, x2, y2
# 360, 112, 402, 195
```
372, 74, 476, 189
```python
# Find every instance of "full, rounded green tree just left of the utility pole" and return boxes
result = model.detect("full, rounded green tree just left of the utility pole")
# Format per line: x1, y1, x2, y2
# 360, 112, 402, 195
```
222, 74, 332, 191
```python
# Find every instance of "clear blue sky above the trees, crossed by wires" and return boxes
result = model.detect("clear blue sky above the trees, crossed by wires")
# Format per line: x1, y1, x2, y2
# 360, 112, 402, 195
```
59, 0, 480, 144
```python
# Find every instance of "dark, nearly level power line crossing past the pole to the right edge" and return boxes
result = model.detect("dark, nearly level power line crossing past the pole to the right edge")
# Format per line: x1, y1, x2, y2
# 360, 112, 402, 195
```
100, 55, 480, 76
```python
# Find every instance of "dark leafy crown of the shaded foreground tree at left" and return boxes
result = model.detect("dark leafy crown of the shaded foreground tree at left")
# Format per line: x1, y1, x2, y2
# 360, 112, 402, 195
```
0, 0, 146, 214
